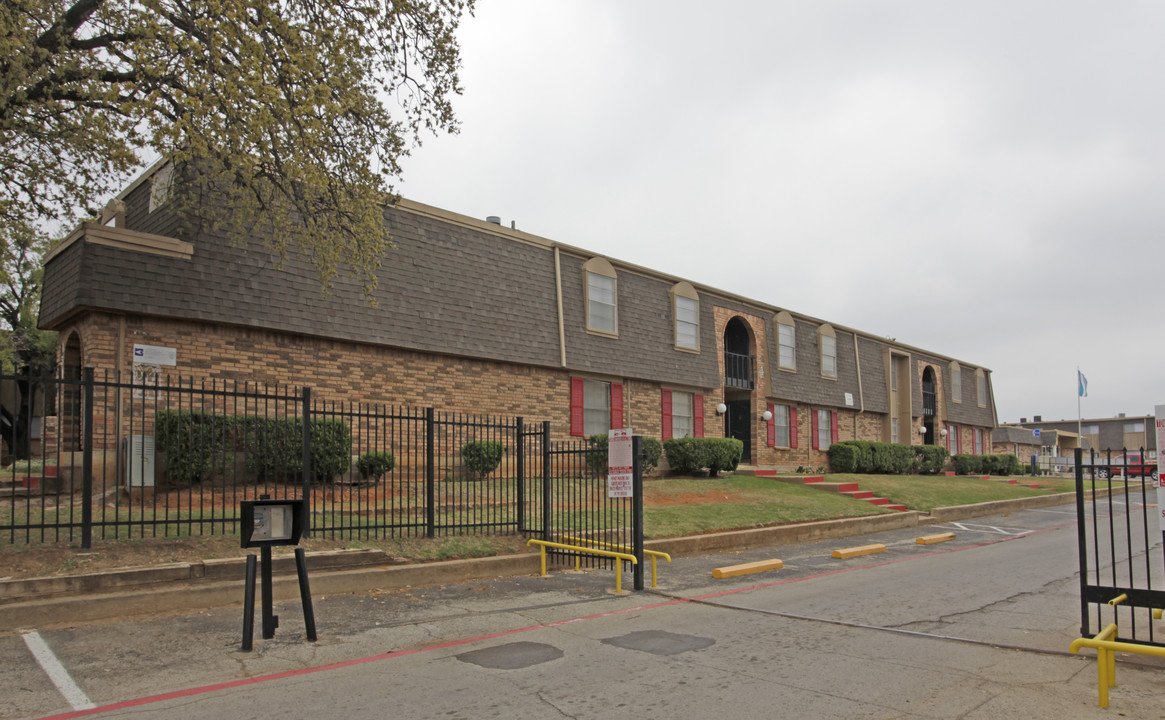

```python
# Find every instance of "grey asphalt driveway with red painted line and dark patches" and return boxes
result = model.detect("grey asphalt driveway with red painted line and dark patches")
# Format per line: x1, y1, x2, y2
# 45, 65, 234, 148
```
0, 498, 1165, 720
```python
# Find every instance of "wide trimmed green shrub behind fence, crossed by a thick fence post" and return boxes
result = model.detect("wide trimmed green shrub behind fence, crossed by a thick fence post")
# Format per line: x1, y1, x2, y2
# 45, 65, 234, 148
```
247, 417, 352, 482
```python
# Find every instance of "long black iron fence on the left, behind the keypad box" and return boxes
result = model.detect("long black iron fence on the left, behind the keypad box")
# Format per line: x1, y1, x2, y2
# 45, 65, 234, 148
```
0, 369, 631, 547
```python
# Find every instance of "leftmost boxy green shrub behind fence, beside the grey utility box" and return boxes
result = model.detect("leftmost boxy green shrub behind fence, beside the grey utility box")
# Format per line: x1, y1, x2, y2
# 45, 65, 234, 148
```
154, 410, 233, 485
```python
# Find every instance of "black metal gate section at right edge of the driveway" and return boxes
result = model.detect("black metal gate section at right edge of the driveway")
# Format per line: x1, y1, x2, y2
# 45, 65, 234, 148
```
1075, 449, 1165, 647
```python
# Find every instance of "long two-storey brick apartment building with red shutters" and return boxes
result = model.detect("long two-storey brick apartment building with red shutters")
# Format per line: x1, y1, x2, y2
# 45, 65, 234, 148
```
40, 159, 996, 467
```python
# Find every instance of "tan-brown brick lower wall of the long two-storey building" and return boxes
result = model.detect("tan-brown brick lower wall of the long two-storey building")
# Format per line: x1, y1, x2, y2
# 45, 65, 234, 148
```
47, 308, 992, 468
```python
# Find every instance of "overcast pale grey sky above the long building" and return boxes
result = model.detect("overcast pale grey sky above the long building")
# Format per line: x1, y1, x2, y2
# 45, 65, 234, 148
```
397, 0, 1165, 422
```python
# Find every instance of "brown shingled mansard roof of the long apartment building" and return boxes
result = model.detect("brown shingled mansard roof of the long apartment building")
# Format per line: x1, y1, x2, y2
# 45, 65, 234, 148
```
40, 160, 994, 416
